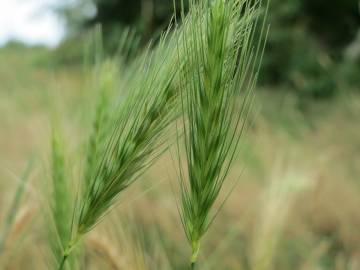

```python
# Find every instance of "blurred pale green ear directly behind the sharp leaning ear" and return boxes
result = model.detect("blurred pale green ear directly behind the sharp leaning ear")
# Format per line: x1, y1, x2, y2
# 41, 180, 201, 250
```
82, 26, 139, 198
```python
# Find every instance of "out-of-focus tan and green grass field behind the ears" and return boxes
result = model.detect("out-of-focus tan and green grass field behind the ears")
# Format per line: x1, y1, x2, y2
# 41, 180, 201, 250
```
0, 46, 360, 270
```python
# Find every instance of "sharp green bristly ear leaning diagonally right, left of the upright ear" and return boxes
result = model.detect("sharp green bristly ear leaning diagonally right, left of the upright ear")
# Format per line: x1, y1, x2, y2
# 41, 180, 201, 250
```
58, 26, 179, 269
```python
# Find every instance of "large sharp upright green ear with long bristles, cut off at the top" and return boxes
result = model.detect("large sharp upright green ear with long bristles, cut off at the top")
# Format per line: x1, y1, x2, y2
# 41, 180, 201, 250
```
178, 0, 263, 267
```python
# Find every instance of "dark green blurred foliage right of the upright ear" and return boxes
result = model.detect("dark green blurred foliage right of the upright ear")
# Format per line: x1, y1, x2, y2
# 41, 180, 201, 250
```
261, 0, 360, 101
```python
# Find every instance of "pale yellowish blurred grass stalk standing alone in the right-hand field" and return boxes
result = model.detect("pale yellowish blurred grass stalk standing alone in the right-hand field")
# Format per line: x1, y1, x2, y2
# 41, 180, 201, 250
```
251, 157, 316, 270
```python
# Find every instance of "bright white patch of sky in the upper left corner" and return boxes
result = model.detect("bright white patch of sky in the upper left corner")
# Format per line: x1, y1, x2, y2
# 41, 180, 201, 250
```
0, 0, 65, 47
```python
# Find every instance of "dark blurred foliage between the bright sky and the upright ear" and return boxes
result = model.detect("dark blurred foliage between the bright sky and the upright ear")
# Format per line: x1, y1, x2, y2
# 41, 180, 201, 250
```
58, 0, 188, 43
